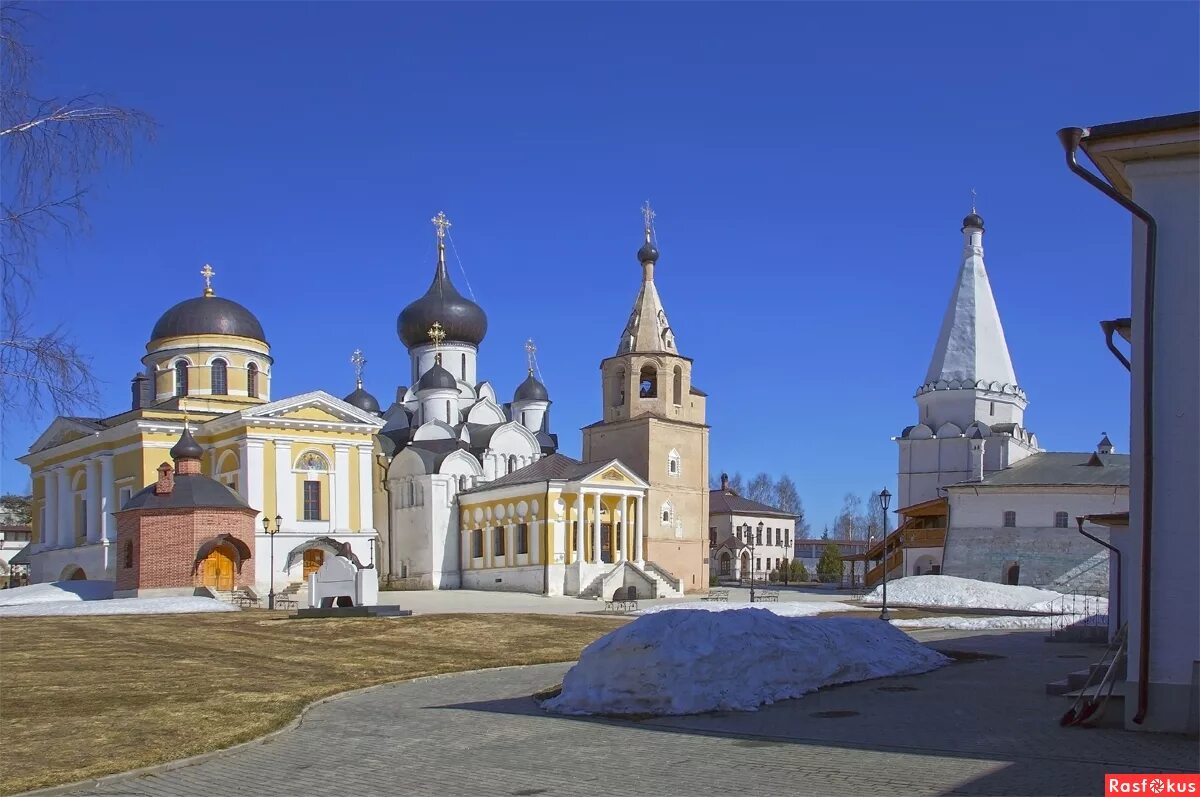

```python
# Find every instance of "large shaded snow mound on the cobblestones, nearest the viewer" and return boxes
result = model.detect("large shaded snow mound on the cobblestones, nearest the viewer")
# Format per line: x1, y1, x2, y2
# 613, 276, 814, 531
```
542, 609, 949, 715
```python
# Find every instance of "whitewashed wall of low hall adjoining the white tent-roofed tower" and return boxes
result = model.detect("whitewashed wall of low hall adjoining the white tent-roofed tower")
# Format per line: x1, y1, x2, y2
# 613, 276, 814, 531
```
942, 487, 1129, 589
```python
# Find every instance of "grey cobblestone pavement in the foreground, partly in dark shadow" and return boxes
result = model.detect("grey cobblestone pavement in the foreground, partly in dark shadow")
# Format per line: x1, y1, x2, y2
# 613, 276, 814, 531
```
46, 631, 1198, 797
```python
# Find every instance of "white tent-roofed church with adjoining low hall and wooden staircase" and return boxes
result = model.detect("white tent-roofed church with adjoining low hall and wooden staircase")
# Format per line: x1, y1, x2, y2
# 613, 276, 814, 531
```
888, 209, 1129, 591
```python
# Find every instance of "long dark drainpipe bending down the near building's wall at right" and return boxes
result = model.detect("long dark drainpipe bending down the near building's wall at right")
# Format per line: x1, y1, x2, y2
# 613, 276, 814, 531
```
1058, 127, 1158, 725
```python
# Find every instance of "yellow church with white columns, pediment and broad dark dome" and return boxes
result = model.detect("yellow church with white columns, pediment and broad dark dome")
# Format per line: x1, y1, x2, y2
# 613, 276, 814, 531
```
19, 266, 383, 591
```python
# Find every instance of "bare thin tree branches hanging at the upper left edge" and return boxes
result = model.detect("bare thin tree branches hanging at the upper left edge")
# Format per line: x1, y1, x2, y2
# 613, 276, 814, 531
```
0, 4, 155, 417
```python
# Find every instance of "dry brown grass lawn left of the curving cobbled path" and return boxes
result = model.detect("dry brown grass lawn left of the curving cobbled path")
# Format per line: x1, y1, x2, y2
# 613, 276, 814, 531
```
0, 611, 625, 795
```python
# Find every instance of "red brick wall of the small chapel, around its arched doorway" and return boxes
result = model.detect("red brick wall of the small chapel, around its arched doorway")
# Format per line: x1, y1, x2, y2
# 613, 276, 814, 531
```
116, 508, 254, 591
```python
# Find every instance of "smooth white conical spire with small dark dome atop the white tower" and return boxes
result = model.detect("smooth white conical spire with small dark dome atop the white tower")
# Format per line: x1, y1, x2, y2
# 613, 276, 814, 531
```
925, 210, 1016, 385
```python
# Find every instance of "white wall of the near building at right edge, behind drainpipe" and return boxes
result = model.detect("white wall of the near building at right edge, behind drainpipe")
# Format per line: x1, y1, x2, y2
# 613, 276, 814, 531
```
1114, 155, 1200, 732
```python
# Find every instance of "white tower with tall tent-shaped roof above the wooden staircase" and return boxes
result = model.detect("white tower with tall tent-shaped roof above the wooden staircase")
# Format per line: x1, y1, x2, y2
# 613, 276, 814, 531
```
896, 208, 1039, 508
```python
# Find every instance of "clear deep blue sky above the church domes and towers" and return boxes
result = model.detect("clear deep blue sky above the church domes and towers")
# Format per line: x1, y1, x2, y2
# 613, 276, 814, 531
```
0, 2, 1200, 531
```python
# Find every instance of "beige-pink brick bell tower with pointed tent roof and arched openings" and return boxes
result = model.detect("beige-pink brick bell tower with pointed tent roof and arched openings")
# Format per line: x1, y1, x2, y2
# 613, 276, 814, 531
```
583, 202, 709, 592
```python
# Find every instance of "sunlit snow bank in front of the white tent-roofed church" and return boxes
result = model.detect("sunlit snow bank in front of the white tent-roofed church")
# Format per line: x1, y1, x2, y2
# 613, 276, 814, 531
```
863, 576, 1109, 615
